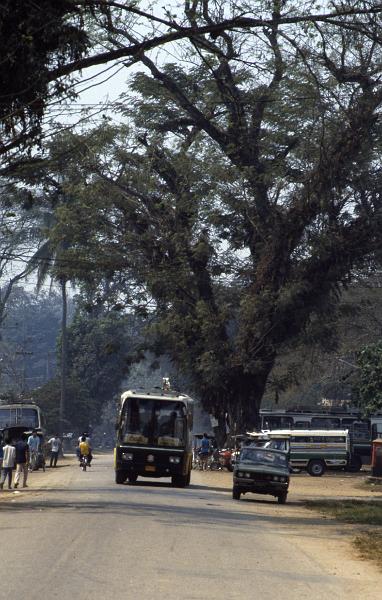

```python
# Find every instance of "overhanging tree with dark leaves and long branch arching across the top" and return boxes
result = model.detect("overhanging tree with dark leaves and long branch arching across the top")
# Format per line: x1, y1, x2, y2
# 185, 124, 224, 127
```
0, 0, 382, 161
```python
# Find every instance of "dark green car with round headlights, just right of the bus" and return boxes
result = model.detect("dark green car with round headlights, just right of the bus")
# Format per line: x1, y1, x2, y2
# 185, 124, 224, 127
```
232, 446, 289, 504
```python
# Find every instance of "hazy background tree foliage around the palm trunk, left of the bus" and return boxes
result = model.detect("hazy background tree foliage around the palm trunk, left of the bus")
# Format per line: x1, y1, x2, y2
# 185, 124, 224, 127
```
32, 307, 140, 432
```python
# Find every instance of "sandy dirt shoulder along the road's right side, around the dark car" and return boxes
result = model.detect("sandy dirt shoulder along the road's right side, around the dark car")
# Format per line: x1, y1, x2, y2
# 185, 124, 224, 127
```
191, 464, 382, 600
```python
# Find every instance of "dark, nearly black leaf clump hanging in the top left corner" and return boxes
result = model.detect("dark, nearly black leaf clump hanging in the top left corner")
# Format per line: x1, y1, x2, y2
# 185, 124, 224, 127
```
0, 0, 89, 153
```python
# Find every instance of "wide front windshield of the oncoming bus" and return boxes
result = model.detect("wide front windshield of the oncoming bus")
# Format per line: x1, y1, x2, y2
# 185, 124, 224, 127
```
120, 398, 186, 447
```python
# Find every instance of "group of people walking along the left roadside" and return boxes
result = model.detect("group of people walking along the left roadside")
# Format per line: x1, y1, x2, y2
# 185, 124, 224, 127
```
0, 429, 61, 490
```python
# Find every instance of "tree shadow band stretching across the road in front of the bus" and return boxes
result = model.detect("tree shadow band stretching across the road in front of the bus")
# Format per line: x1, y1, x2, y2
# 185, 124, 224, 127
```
0, 490, 346, 539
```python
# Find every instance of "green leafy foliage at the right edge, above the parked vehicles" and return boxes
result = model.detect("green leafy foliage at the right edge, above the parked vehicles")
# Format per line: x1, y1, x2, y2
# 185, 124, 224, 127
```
355, 341, 382, 414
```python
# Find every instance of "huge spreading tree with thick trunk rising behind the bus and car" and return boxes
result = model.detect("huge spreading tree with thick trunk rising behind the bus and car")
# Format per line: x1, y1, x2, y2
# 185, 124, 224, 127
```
8, 0, 382, 426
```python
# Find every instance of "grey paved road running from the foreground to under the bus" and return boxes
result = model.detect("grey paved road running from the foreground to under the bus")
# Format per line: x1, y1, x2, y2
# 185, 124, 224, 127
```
0, 456, 381, 600
